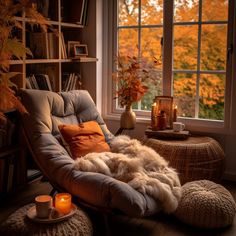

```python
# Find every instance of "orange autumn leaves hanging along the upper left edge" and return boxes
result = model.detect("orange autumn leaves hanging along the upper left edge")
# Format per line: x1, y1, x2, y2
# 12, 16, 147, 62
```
0, 0, 48, 122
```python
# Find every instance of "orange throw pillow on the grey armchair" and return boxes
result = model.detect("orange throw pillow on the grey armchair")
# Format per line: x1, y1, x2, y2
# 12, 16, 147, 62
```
58, 121, 110, 159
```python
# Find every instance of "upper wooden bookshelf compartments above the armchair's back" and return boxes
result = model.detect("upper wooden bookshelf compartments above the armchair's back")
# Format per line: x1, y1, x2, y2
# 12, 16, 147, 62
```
10, 0, 98, 92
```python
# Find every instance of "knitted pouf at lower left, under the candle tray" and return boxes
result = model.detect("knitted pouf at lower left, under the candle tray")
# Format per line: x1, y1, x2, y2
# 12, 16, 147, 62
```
0, 204, 93, 236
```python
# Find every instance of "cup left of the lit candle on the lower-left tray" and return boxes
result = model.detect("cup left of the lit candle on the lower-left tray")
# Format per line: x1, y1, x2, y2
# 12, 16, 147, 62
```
35, 195, 53, 218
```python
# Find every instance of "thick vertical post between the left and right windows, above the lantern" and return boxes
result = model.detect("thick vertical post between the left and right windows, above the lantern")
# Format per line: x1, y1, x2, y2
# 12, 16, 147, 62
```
162, 0, 174, 96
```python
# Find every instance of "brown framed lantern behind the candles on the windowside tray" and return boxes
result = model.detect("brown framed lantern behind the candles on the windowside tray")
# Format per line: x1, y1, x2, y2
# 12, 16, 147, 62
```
154, 96, 173, 129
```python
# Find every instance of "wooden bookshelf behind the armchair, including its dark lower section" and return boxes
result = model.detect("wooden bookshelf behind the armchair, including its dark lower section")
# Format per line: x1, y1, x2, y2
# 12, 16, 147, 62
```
0, 0, 98, 195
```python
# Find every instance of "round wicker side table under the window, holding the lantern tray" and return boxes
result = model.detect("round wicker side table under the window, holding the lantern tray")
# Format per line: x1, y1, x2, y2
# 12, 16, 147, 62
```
144, 137, 225, 184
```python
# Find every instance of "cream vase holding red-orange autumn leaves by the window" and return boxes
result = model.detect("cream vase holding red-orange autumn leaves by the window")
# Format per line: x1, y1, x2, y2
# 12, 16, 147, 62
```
120, 105, 136, 129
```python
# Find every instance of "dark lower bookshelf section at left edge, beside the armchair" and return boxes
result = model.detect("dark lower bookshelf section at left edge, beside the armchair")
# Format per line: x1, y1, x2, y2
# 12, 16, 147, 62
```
0, 110, 27, 198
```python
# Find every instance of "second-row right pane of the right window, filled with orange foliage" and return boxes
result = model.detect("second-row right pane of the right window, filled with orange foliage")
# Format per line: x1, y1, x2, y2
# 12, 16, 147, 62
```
201, 24, 227, 70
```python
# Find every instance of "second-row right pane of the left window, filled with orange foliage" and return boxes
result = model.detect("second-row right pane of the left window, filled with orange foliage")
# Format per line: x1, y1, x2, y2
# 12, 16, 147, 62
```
141, 28, 163, 69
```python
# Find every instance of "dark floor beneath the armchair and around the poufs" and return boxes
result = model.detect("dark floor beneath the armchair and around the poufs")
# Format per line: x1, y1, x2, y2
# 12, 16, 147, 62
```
0, 180, 236, 236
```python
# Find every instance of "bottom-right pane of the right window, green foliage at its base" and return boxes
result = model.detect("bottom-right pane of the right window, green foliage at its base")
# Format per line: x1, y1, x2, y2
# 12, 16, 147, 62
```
199, 74, 225, 120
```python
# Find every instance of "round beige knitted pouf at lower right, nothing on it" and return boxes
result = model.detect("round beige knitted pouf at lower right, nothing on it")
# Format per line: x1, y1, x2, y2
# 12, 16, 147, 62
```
175, 180, 236, 228
